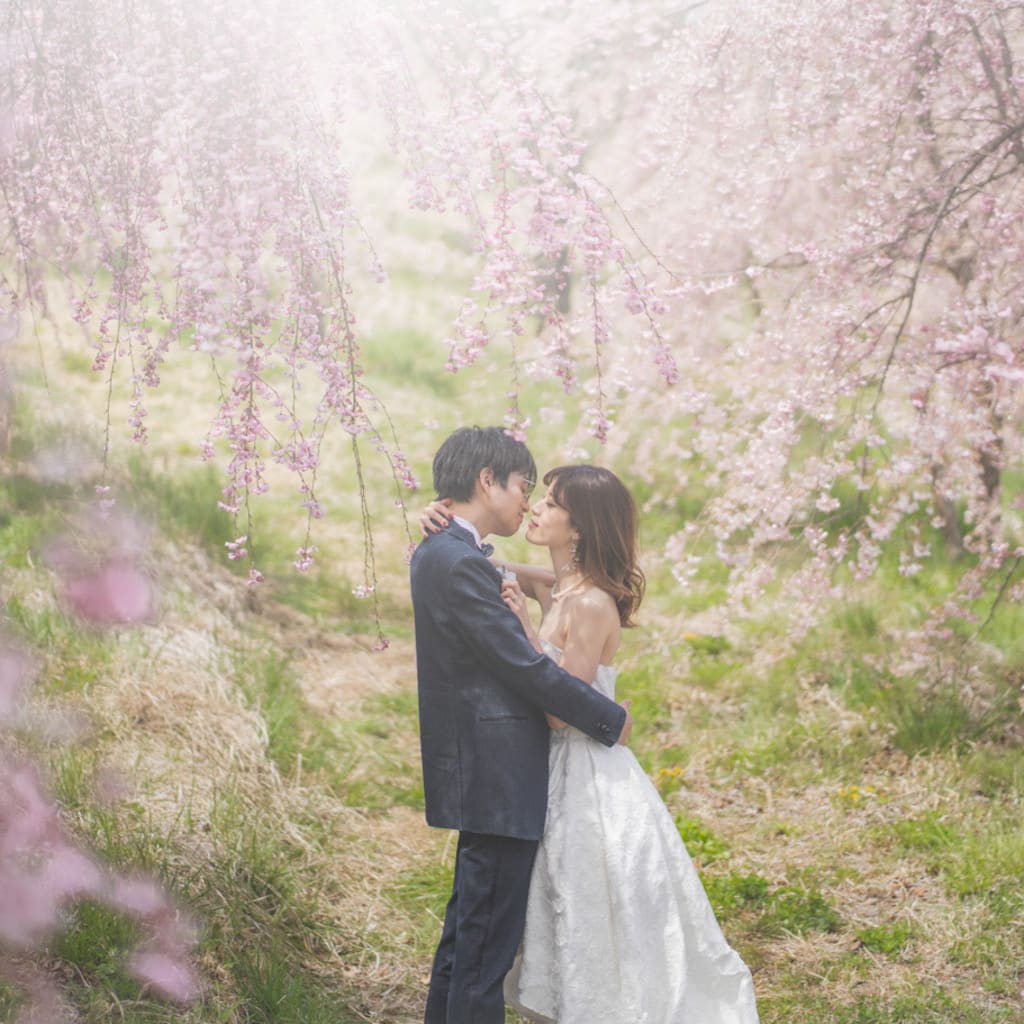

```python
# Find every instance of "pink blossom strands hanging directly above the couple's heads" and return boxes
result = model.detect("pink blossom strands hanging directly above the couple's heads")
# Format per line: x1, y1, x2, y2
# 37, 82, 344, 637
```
368, 3, 678, 440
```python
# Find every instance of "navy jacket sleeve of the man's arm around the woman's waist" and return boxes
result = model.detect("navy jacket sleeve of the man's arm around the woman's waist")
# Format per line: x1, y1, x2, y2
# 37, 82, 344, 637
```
446, 556, 626, 746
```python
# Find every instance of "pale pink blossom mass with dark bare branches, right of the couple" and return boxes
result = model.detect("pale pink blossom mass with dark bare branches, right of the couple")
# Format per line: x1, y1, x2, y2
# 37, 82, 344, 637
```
552, 0, 1024, 643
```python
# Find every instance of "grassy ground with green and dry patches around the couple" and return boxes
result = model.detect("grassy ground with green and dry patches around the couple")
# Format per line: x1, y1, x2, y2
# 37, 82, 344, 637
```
0, 331, 1024, 1024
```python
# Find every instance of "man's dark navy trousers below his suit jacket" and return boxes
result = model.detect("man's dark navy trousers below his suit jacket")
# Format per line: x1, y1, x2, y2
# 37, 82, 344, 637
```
424, 833, 538, 1024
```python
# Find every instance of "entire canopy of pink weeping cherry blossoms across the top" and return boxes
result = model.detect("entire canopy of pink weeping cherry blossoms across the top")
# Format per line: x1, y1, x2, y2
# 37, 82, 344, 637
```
2, 0, 1024, 655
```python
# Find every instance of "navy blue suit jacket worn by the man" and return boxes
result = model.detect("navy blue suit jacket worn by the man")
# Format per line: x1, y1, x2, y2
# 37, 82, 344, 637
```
412, 523, 626, 839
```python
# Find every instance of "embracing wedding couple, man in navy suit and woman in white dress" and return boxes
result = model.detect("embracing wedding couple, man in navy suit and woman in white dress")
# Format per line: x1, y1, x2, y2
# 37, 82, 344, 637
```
412, 427, 758, 1024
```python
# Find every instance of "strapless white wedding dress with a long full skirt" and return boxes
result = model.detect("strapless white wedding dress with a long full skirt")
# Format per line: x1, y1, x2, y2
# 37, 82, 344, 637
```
505, 645, 758, 1024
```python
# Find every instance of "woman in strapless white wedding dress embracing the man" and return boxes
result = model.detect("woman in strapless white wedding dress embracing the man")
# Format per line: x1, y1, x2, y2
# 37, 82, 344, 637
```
428, 466, 758, 1024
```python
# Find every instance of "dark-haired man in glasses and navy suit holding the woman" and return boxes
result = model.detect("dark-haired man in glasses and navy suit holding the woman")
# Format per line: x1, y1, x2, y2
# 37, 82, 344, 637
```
412, 427, 633, 1024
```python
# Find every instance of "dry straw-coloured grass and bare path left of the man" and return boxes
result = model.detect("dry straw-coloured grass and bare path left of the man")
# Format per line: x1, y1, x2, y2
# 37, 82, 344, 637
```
97, 550, 443, 1024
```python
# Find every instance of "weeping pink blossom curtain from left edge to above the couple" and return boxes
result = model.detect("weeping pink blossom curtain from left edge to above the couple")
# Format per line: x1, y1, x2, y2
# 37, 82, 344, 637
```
0, 0, 677, 622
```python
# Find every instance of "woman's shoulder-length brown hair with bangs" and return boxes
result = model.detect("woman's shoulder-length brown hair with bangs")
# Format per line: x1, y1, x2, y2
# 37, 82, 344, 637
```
544, 465, 646, 626
